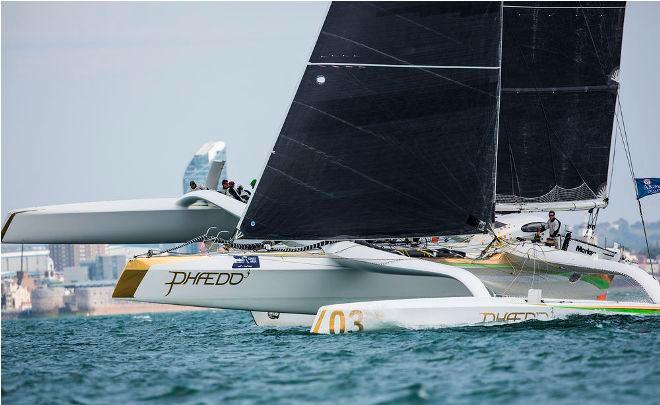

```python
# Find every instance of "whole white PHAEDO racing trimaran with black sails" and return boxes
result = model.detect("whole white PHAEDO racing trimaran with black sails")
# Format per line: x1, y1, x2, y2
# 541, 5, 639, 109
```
2, 2, 660, 333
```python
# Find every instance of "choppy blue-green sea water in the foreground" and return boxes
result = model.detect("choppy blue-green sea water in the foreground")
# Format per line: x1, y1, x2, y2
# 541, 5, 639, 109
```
2, 311, 660, 404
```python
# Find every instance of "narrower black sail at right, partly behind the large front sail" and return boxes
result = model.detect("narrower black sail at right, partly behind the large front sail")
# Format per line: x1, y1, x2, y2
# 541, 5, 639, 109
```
497, 2, 625, 210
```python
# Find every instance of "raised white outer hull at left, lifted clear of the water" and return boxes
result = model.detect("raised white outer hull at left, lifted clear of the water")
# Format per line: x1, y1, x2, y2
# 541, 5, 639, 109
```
2, 190, 245, 243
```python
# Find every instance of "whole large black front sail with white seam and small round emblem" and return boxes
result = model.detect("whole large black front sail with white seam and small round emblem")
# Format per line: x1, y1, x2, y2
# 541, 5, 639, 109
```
239, 2, 502, 240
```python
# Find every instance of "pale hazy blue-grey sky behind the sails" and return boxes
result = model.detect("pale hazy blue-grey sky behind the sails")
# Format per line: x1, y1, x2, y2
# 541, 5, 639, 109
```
1, 2, 660, 224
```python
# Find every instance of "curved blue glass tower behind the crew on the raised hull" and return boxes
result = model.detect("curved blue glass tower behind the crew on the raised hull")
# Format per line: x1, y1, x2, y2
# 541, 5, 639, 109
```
183, 141, 227, 193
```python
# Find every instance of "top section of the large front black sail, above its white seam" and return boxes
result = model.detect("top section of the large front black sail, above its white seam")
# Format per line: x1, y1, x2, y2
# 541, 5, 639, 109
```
310, 2, 500, 66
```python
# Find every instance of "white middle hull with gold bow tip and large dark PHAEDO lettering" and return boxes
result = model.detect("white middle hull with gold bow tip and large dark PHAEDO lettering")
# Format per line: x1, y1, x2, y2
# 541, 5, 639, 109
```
113, 254, 471, 315
